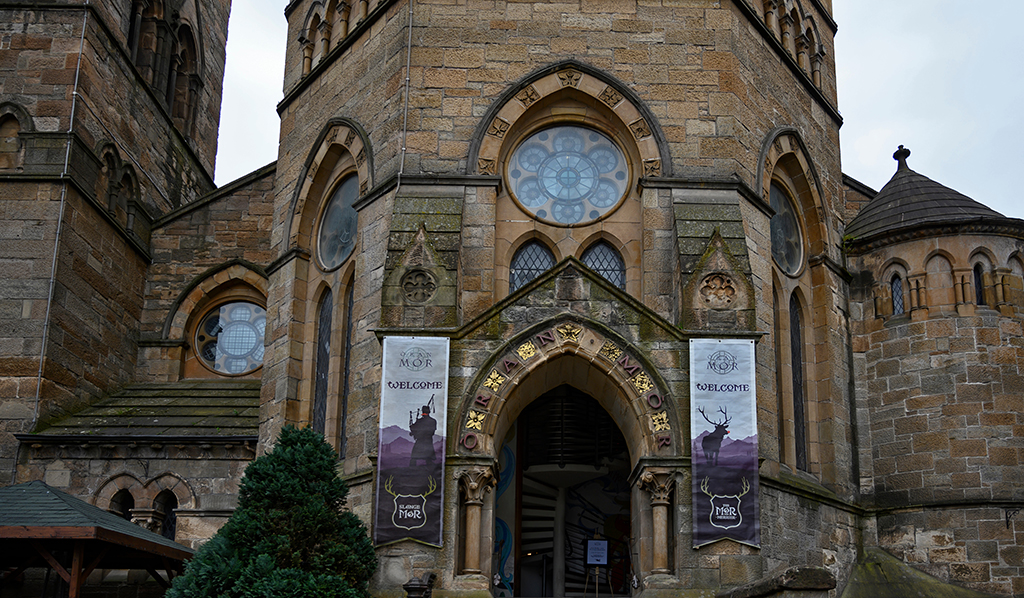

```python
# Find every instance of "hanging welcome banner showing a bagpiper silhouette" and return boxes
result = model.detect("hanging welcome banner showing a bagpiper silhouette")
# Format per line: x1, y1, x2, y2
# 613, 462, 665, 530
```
374, 337, 449, 546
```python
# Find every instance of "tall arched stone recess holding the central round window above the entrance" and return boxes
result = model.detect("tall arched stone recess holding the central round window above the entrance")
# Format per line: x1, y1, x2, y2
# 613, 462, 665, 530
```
467, 60, 671, 300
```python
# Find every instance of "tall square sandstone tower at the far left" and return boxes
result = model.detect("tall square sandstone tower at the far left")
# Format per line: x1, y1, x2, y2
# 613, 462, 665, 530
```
0, 0, 230, 482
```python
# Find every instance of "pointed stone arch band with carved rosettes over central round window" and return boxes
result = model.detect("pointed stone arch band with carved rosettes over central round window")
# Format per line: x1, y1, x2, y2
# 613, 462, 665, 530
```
466, 59, 672, 176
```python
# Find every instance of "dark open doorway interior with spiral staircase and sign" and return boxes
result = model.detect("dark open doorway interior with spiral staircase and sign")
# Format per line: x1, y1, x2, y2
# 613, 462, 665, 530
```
493, 385, 632, 597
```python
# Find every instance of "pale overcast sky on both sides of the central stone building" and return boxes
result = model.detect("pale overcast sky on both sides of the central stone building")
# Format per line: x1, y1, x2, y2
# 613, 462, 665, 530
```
216, 0, 1024, 218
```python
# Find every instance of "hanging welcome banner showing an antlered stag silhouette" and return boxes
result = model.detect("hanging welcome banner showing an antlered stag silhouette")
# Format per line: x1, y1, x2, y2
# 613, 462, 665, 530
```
690, 339, 761, 548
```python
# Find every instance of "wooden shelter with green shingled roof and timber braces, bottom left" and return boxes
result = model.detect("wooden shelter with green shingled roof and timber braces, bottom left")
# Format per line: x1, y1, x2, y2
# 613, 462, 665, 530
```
0, 481, 193, 598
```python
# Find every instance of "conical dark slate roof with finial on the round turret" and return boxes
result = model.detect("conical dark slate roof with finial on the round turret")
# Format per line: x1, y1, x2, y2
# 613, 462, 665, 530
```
846, 145, 1007, 243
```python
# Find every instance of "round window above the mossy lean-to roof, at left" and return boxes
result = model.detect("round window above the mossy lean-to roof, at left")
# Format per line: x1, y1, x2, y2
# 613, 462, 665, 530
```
196, 301, 266, 375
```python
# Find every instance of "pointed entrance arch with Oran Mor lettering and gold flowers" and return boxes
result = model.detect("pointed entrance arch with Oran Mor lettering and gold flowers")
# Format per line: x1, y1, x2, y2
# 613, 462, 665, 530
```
451, 315, 684, 466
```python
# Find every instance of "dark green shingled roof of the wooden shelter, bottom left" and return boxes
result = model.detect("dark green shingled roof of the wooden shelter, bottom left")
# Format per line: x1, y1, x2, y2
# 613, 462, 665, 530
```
0, 481, 193, 560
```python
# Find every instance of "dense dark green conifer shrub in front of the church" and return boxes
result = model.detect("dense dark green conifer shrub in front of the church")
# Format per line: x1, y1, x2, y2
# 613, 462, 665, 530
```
167, 426, 377, 598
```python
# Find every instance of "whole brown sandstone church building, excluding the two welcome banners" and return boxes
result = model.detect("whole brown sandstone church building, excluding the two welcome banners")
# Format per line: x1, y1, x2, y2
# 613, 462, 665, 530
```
0, 0, 1024, 596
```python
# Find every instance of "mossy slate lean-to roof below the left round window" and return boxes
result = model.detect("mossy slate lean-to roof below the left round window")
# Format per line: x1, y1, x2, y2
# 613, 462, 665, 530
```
35, 380, 260, 437
